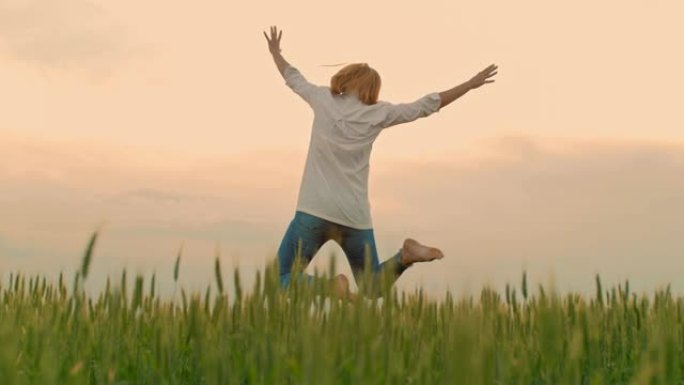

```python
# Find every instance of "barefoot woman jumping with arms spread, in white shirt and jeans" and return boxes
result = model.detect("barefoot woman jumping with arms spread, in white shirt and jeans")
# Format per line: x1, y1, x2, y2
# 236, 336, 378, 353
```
264, 27, 497, 297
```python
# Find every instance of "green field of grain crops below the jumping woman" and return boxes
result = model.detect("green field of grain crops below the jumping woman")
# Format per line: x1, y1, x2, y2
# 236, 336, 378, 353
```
0, 230, 684, 385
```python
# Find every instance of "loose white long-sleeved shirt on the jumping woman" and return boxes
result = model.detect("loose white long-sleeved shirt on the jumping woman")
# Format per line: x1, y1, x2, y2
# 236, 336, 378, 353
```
283, 65, 441, 229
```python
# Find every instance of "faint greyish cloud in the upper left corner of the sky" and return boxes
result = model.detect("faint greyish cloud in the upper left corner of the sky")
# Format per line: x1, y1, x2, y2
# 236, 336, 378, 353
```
0, 0, 138, 76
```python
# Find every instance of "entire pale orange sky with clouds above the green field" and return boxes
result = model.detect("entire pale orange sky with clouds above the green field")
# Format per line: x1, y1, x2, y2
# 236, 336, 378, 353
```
0, 0, 684, 294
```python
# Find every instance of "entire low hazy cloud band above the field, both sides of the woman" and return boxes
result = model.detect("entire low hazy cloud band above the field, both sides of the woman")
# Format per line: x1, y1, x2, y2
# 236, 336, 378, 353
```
0, 137, 684, 293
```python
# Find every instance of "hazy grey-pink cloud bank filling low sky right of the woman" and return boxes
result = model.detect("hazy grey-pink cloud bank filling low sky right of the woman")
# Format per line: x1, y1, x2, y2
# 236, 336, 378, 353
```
374, 139, 684, 289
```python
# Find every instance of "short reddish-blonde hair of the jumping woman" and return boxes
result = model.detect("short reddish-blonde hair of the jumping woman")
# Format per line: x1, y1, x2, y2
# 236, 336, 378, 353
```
330, 63, 381, 105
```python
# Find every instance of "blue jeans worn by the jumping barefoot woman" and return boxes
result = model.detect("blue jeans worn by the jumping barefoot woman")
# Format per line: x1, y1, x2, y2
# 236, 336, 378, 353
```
278, 211, 407, 294
